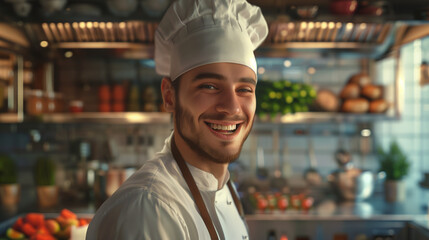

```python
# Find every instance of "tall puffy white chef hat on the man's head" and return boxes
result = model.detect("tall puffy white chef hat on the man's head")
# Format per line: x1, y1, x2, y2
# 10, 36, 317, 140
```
155, 0, 268, 80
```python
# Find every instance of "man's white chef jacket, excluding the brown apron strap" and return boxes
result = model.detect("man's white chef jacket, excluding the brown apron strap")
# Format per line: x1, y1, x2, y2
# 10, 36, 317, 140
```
86, 136, 248, 240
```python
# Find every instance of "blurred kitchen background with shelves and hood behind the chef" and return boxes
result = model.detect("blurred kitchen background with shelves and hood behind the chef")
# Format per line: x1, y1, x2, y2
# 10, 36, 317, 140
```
0, 0, 429, 239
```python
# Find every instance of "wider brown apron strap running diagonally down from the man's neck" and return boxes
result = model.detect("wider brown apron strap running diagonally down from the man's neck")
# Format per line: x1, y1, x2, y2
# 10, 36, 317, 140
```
171, 139, 219, 240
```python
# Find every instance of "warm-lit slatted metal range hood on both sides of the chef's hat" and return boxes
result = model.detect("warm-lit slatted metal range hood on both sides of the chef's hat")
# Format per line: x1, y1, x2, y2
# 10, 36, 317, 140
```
20, 17, 396, 57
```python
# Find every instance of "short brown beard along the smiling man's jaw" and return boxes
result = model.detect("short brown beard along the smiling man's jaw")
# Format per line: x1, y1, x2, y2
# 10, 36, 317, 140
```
175, 98, 253, 164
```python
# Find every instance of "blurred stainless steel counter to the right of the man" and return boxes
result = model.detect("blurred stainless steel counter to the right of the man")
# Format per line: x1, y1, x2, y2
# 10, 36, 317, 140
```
246, 189, 429, 240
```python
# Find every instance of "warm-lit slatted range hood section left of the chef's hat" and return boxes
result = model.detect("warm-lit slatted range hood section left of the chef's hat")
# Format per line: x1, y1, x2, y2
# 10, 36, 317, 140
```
25, 20, 158, 48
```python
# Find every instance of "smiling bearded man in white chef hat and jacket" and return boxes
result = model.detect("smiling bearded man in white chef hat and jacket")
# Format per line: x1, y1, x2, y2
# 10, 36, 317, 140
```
87, 0, 268, 240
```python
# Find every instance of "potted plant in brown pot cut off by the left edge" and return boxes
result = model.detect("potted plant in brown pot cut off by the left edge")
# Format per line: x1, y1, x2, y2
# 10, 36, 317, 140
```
0, 154, 20, 210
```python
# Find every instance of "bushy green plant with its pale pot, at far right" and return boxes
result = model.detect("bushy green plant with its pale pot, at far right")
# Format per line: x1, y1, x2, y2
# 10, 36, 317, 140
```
377, 141, 410, 202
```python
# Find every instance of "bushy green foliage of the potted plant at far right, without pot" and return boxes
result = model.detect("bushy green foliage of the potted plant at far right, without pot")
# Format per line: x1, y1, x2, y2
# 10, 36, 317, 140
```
377, 141, 410, 180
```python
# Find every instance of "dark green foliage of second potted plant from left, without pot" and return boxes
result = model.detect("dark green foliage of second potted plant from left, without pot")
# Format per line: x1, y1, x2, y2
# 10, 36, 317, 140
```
34, 157, 56, 186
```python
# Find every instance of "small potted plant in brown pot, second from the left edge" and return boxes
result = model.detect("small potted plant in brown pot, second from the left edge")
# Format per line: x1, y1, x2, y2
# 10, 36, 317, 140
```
34, 157, 58, 208
